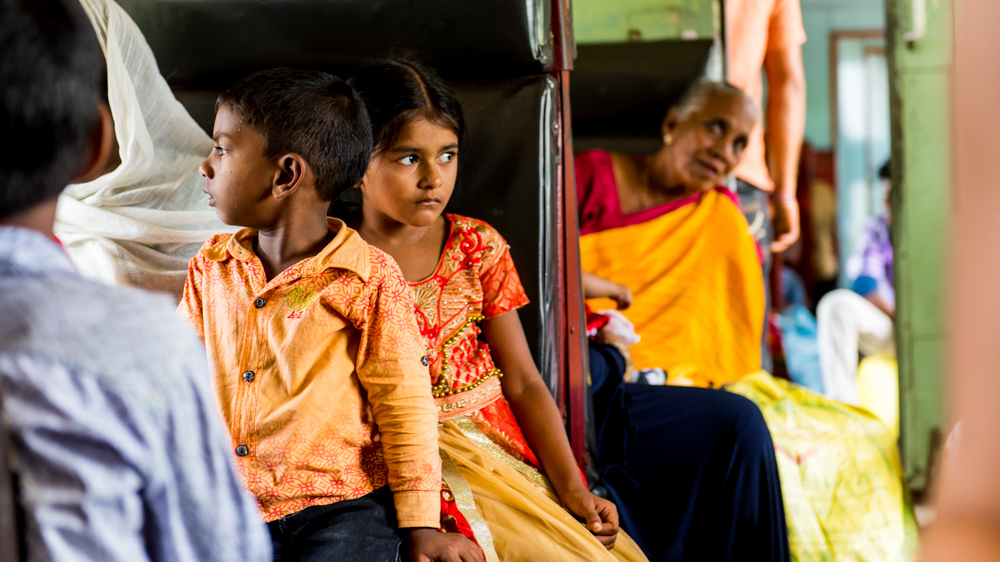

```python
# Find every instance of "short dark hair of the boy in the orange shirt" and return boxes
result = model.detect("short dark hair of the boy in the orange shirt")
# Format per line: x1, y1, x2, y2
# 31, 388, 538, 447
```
215, 68, 372, 201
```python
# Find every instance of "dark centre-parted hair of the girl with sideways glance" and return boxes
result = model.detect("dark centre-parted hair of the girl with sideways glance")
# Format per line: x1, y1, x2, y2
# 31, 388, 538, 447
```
348, 59, 465, 152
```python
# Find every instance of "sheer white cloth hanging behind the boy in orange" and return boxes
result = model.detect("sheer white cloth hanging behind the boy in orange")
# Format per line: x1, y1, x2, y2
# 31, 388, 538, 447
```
55, 0, 233, 297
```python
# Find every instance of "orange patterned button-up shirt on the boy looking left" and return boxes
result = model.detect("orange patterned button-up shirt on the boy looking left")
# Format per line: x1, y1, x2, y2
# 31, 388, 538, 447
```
179, 219, 441, 527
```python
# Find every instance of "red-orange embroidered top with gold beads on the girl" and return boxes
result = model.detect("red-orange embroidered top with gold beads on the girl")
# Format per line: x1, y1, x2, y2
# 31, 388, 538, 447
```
410, 214, 538, 467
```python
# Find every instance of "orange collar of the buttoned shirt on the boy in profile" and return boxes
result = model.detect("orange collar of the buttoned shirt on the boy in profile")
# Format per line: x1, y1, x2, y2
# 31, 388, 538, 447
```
201, 217, 371, 282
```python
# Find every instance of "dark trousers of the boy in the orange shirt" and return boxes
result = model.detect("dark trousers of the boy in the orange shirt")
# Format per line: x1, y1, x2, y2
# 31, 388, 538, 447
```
267, 486, 403, 562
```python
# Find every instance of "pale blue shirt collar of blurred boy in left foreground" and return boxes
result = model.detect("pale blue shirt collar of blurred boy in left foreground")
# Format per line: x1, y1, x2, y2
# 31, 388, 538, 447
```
0, 226, 76, 275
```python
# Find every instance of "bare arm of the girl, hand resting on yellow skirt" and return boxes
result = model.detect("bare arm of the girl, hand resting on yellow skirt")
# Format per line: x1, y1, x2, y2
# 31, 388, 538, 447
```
483, 311, 618, 549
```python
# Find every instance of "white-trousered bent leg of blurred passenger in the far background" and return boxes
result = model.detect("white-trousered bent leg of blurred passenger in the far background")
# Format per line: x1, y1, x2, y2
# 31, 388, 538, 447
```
816, 289, 896, 405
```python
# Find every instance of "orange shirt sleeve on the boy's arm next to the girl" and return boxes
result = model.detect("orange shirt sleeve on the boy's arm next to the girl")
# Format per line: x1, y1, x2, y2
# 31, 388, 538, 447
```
357, 258, 441, 529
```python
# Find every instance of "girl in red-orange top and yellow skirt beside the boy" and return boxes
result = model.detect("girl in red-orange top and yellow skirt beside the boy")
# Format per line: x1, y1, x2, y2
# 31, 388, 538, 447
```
350, 61, 645, 561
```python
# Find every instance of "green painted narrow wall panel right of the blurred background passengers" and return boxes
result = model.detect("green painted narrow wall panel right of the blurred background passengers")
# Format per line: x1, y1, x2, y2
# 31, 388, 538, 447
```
888, 0, 953, 490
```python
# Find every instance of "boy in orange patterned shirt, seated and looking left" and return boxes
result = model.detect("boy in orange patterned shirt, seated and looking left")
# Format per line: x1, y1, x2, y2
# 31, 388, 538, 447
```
180, 69, 458, 561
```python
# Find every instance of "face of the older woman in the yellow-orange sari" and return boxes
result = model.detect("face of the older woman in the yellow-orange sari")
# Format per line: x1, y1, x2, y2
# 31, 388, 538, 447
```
663, 92, 757, 191
